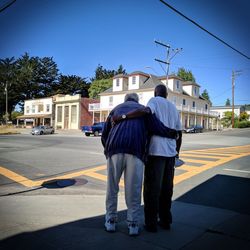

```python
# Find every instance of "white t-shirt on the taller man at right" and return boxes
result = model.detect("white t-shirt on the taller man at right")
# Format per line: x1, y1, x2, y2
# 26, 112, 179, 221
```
147, 96, 181, 157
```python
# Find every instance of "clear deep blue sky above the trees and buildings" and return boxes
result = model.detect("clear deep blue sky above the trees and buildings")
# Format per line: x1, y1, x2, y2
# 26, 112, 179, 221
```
0, 0, 250, 105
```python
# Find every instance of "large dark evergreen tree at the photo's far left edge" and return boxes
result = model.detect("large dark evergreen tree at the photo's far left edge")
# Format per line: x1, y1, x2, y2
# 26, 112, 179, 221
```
0, 53, 58, 118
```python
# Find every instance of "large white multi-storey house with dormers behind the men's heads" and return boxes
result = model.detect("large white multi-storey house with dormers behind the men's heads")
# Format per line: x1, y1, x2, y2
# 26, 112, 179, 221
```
89, 71, 218, 129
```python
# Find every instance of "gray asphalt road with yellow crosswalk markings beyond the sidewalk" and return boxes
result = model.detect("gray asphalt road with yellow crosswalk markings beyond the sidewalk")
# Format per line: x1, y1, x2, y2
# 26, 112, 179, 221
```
0, 129, 250, 199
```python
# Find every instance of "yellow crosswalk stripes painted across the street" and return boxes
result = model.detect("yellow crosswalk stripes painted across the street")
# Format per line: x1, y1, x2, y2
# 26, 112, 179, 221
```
0, 145, 250, 187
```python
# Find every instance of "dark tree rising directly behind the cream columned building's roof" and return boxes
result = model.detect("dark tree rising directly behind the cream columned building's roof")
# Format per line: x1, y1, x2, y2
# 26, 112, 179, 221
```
53, 75, 90, 97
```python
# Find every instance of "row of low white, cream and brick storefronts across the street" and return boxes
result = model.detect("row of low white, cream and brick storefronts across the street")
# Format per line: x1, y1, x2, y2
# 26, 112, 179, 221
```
17, 94, 98, 129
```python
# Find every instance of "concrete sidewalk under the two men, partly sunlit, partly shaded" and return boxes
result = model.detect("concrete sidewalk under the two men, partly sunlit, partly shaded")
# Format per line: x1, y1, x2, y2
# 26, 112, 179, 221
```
0, 194, 250, 250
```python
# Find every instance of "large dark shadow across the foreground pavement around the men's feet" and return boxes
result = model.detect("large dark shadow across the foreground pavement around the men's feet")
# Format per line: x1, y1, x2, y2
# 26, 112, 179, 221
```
0, 175, 250, 250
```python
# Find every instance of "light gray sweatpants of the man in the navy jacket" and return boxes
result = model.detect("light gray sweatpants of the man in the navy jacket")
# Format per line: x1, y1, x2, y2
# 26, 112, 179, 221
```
106, 153, 144, 223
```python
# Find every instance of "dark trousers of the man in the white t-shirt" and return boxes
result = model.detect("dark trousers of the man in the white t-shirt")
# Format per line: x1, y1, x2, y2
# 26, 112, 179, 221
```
143, 156, 175, 226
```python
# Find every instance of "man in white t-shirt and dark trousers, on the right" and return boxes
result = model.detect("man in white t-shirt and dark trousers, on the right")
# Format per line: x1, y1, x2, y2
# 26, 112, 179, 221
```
144, 85, 181, 232
